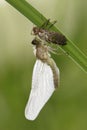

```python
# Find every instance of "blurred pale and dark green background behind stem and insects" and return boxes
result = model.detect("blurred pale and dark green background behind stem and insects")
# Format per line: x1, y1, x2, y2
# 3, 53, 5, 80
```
0, 0, 87, 130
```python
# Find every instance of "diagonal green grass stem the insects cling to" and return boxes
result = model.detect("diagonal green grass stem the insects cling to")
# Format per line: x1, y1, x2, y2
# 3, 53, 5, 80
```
6, 0, 87, 72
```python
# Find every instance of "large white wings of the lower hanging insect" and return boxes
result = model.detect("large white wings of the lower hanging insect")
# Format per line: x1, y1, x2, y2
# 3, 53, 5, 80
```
25, 60, 55, 120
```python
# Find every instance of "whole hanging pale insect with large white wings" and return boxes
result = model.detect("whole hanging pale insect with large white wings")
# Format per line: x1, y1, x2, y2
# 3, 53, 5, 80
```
25, 38, 59, 120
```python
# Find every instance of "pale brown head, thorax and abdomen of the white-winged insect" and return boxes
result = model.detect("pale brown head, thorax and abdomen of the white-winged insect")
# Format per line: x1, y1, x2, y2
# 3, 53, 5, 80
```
32, 38, 60, 88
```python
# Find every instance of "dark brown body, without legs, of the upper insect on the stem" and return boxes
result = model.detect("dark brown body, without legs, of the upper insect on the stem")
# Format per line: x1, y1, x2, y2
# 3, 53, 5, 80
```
33, 27, 67, 45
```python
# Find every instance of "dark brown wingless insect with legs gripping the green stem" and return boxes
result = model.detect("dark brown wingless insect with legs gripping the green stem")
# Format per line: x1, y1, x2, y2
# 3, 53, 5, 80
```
32, 19, 67, 46
